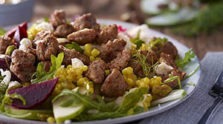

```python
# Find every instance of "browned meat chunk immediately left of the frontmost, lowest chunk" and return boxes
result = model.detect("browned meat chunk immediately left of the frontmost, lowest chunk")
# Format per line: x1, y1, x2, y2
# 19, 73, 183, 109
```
86, 59, 106, 84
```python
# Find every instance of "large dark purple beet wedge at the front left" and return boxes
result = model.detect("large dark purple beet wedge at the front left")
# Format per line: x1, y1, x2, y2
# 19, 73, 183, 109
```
8, 78, 58, 109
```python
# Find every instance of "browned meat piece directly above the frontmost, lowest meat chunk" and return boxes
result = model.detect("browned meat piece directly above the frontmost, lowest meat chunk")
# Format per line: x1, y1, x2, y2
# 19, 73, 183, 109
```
108, 50, 131, 70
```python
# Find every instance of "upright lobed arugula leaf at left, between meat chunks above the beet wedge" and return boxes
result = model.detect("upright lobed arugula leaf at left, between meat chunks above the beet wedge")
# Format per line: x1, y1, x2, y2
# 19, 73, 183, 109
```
31, 53, 64, 83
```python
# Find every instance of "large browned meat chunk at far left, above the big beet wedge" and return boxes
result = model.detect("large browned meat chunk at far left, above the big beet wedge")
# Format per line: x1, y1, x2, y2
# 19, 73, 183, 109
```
10, 49, 36, 82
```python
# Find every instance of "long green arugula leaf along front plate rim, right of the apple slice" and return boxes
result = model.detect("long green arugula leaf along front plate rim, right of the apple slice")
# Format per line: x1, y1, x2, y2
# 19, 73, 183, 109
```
75, 88, 148, 121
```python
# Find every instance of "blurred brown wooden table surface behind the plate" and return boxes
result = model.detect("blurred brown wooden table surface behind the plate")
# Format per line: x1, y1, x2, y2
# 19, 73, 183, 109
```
33, 0, 223, 59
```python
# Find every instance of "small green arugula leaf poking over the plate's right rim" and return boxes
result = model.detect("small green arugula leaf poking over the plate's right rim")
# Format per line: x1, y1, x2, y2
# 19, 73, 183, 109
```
176, 49, 195, 68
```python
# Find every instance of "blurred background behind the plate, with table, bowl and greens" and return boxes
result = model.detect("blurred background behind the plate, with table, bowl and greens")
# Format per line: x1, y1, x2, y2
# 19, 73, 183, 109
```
0, 0, 223, 58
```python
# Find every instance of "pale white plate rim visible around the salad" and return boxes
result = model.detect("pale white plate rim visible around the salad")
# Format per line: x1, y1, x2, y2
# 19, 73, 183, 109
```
0, 20, 201, 124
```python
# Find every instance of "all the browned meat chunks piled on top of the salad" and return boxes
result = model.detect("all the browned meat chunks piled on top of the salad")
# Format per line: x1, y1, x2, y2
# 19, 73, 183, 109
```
0, 10, 184, 97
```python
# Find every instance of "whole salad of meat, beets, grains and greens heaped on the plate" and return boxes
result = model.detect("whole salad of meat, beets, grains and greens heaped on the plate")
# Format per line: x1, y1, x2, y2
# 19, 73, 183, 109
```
0, 10, 195, 123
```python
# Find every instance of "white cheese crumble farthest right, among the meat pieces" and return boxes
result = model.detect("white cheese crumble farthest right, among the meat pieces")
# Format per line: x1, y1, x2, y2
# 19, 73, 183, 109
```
155, 62, 173, 75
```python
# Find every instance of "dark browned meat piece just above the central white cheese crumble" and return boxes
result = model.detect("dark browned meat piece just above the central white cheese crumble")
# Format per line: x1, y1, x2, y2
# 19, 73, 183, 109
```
59, 45, 90, 65
